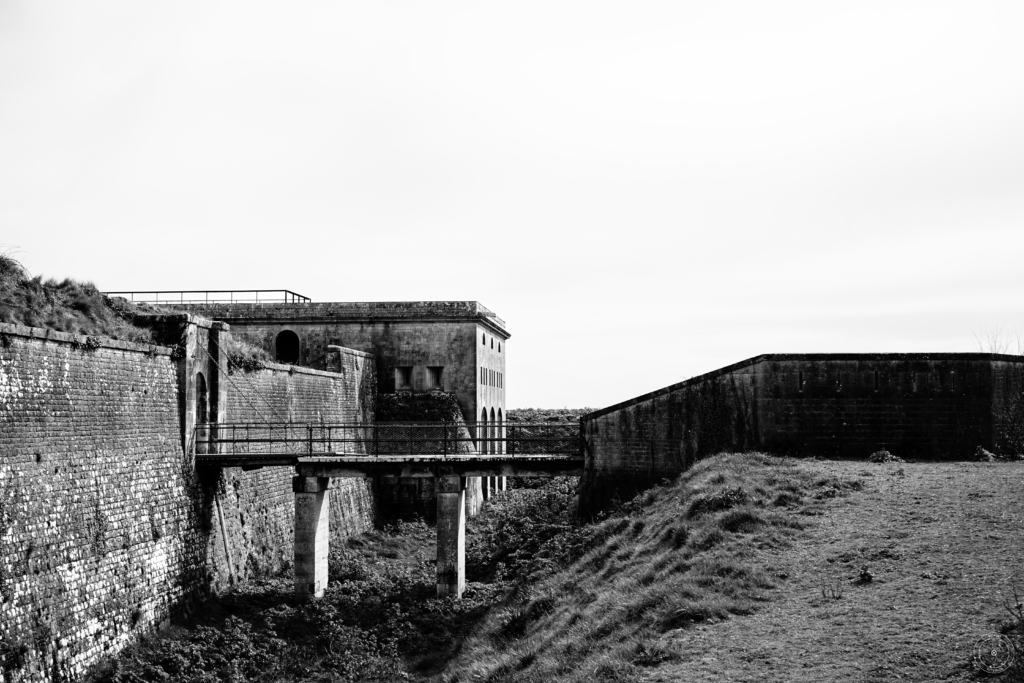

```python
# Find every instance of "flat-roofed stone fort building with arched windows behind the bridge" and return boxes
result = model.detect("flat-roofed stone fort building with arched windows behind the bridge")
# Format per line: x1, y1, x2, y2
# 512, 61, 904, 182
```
176, 295, 511, 519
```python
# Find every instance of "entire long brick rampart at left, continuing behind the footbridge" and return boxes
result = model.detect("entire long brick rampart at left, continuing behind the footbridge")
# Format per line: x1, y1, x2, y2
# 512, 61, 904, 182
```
0, 325, 374, 681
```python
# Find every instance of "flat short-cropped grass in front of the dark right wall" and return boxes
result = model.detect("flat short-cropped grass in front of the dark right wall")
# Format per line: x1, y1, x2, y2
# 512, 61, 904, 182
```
643, 461, 1024, 683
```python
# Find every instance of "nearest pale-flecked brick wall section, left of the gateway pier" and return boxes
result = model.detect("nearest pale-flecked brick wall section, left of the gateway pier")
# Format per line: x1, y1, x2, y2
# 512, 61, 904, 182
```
0, 325, 206, 680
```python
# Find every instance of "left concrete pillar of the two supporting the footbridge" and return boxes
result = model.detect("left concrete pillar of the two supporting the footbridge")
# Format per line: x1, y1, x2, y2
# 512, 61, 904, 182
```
292, 476, 331, 600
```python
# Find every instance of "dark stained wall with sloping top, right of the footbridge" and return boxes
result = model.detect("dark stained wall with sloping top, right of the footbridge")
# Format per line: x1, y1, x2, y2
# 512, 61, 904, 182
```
580, 353, 1024, 516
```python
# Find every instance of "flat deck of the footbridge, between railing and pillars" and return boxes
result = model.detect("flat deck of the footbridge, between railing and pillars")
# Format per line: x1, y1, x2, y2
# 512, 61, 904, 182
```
196, 454, 584, 478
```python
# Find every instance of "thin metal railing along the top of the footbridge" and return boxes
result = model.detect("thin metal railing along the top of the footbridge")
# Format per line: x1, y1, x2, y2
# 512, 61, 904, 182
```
195, 422, 583, 456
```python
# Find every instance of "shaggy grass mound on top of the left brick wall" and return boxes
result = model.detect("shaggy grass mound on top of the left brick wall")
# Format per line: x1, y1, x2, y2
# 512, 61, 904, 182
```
0, 254, 153, 343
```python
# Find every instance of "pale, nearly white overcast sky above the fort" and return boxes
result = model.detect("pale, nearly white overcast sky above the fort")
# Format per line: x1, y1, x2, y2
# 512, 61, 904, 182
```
0, 0, 1024, 408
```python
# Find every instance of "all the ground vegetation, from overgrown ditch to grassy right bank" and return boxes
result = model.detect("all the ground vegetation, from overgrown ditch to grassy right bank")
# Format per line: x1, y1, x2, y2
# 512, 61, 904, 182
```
81, 454, 1024, 683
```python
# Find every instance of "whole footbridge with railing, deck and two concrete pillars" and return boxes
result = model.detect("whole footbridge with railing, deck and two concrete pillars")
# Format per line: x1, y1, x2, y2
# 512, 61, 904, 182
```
193, 422, 585, 598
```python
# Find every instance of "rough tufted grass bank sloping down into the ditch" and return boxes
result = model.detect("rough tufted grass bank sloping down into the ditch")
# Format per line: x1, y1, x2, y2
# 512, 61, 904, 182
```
444, 454, 860, 681
